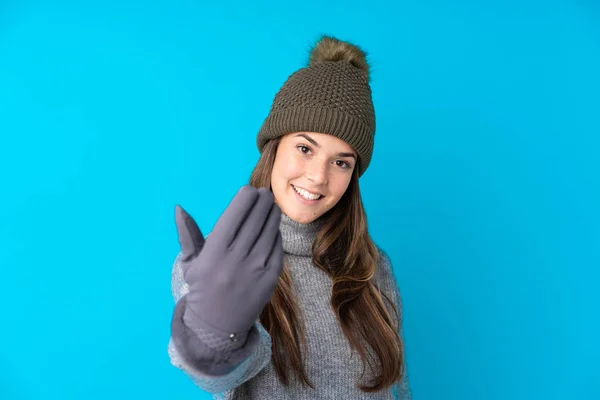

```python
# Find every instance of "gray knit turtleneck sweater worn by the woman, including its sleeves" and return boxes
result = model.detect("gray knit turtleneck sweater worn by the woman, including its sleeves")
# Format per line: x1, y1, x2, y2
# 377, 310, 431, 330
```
168, 214, 412, 400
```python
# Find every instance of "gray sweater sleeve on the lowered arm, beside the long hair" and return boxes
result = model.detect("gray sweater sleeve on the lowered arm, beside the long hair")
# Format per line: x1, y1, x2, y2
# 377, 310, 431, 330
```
379, 249, 412, 400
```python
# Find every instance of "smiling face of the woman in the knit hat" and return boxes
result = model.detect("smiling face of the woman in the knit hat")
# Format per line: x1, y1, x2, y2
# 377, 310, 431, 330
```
271, 132, 358, 223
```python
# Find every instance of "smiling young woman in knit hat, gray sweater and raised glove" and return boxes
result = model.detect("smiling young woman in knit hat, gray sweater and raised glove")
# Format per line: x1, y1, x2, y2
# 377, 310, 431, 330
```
169, 36, 411, 400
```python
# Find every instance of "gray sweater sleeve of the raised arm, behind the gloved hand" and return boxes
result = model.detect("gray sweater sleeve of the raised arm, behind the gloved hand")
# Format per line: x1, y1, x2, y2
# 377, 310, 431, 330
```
168, 254, 271, 394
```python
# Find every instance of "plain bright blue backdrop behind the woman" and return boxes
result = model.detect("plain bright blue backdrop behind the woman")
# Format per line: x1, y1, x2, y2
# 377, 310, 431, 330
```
0, 0, 600, 400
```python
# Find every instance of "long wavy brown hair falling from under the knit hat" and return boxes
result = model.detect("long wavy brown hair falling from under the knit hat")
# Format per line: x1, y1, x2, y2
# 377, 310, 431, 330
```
250, 139, 404, 392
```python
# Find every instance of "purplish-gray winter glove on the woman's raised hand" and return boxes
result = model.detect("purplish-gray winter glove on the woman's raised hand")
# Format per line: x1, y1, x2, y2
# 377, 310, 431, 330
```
172, 186, 283, 374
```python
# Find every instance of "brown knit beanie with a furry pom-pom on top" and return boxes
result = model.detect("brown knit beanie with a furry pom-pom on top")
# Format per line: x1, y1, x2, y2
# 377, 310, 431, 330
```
256, 36, 375, 176
